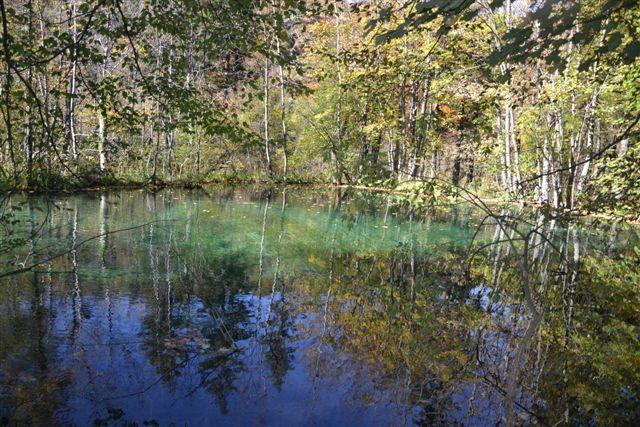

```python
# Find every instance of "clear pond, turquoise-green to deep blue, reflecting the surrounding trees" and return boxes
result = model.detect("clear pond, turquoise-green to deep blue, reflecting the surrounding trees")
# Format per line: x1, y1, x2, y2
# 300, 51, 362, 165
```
0, 188, 640, 426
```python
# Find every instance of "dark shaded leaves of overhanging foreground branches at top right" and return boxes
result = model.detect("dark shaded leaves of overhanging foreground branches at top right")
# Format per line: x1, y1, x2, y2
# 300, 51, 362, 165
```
371, 0, 640, 73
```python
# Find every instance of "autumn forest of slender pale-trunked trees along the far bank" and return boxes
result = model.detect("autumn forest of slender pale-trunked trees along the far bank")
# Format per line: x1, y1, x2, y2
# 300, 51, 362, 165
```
0, 0, 640, 219
